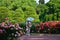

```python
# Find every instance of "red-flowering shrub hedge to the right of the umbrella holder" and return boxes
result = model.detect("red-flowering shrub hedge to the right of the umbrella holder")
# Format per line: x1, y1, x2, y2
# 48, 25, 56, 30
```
36, 21, 60, 33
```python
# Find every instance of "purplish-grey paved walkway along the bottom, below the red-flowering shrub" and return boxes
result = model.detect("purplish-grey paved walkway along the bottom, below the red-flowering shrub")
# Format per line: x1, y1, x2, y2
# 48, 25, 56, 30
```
20, 34, 60, 40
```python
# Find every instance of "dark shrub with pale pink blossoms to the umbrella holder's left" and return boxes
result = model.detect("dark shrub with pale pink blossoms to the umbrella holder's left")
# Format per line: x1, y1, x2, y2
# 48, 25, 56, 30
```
0, 22, 23, 40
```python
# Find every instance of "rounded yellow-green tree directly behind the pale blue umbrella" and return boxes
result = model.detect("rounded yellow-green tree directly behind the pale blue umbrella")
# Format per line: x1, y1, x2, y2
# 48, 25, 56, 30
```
24, 6, 39, 22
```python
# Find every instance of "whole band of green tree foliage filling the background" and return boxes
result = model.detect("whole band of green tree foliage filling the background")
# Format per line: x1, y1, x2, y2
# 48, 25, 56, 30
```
0, 0, 60, 23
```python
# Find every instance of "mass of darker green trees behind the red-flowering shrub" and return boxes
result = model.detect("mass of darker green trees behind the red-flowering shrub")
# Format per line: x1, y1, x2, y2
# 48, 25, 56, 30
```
37, 0, 60, 21
